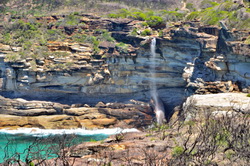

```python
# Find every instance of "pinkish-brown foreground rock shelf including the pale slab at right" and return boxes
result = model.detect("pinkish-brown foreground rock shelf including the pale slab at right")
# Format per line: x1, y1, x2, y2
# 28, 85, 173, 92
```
23, 93, 250, 166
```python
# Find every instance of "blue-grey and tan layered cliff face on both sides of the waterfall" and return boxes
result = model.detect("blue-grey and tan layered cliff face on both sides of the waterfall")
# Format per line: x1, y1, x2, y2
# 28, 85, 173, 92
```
0, 15, 250, 109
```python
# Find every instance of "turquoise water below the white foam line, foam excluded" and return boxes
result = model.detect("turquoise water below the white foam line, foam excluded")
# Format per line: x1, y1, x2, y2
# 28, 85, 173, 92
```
0, 133, 108, 163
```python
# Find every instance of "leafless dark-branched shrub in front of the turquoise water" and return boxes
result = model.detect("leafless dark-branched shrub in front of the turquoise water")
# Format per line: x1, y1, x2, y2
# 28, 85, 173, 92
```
1, 134, 78, 166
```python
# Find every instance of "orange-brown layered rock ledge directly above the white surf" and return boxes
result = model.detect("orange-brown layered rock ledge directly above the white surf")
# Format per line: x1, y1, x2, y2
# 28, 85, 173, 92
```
0, 96, 153, 129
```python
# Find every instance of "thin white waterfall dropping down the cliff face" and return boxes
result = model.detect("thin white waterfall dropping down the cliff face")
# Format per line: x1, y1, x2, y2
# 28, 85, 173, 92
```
150, 38, 165, 124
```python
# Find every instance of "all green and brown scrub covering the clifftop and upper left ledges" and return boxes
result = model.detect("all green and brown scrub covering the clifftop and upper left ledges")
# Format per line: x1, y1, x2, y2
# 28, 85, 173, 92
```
0, 0, 250, 68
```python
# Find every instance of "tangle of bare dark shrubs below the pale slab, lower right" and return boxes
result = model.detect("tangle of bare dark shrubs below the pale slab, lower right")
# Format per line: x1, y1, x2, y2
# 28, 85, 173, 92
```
170, 98, 250, 165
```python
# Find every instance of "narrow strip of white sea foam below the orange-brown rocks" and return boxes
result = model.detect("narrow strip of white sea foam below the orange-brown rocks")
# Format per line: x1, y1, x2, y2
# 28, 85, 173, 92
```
0, 128, 139, 137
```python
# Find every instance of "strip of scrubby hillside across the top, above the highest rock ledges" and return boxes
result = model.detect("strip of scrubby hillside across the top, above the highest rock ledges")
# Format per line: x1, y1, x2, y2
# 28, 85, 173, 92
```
0, 0, 250, 29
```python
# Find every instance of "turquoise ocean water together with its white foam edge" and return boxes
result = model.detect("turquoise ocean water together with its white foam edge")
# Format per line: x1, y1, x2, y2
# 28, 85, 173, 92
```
0, 128, 138, 163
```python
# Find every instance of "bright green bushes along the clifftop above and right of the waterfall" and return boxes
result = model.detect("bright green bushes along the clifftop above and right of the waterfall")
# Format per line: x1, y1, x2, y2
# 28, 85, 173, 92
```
108, 0, 250, 30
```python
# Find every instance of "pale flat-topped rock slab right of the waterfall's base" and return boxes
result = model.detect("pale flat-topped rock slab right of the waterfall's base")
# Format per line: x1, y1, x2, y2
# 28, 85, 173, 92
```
183, 93, 250, 121
